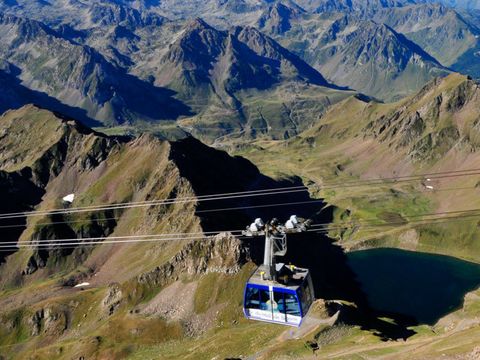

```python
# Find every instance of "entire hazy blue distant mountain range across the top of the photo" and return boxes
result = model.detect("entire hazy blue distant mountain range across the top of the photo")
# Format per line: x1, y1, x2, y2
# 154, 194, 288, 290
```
0, 0, 480, 139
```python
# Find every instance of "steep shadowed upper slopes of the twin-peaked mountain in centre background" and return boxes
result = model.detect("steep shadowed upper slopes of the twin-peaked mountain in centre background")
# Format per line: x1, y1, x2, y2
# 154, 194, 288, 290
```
157, 19, 328, 94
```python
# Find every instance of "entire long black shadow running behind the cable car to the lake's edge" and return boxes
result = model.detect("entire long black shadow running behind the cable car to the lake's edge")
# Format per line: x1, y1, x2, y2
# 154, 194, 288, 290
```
171, 138, 416, 340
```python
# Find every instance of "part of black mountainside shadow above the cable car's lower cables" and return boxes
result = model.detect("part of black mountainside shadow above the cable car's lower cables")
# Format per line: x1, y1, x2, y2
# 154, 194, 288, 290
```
170, 137, 325, 231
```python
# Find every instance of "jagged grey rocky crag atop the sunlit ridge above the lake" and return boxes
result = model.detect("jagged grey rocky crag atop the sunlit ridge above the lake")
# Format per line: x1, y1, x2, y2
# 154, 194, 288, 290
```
364, 79, 479, 161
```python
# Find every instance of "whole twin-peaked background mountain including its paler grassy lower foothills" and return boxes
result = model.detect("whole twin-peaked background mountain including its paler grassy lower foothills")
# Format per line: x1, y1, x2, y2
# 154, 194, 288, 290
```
152, 19, 348, 137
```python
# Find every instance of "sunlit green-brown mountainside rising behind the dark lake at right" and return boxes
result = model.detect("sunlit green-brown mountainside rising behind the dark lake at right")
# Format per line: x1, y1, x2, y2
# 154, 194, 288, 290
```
234, 74, 480, 261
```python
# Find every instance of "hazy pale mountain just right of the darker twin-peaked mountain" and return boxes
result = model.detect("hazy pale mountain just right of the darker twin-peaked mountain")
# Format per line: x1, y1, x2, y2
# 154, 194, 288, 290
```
258, 5, 449, 100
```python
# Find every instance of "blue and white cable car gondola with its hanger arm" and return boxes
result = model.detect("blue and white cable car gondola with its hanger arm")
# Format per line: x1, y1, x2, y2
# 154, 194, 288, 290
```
243, 219, 315, 326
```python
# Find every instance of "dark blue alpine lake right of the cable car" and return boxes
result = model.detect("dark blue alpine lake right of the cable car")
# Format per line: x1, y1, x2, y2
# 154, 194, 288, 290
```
347, 248, 480, 324
